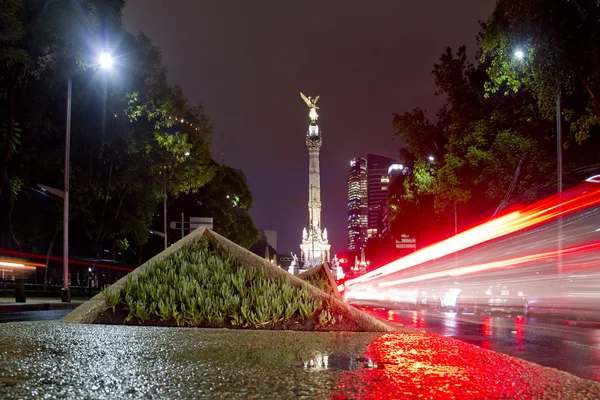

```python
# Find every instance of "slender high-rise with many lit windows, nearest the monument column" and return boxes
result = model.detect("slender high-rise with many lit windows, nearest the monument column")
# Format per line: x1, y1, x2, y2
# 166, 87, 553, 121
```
348, 157, 369, 252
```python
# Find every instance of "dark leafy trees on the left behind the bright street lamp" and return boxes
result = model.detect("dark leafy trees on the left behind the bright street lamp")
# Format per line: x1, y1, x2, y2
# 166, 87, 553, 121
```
0, 0, 255, 266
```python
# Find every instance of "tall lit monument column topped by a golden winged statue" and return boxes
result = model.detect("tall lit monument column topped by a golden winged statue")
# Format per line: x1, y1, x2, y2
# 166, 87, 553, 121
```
300, 93, 331, 269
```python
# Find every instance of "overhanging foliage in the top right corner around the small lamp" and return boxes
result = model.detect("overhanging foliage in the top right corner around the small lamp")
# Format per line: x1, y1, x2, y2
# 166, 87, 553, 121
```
481, 0, 600, 142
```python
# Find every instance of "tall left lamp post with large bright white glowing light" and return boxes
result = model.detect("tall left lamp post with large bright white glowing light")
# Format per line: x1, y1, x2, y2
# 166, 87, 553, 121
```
61, 53, 113, 303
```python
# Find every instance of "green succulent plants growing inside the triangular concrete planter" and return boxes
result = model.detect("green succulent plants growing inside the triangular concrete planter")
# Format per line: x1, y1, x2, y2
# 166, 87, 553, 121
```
103, 238, 342, 328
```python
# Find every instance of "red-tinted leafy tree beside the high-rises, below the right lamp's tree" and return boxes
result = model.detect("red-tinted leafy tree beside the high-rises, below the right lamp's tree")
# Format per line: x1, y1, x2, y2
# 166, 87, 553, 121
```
388, 43, 552, 245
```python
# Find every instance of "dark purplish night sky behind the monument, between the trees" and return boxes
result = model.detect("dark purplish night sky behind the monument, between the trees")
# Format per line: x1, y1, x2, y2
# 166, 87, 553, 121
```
124, 0, 495, 256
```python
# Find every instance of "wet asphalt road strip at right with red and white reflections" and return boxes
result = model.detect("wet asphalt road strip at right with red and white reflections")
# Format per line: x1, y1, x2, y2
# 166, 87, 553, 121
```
386, 310, 600, 381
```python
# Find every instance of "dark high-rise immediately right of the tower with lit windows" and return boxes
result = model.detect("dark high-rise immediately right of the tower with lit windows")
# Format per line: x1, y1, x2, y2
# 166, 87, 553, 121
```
367, 154, 396, 237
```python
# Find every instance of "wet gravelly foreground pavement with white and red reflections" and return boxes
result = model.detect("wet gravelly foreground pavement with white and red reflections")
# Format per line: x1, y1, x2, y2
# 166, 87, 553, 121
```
0, 321, 600, 399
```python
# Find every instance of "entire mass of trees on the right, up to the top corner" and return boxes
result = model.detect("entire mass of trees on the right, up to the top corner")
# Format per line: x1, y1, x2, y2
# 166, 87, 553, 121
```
389, 0, 600, 245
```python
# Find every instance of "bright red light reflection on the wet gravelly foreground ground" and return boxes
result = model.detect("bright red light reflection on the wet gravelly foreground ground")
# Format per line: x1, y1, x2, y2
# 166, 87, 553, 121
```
331, 334, 600, 399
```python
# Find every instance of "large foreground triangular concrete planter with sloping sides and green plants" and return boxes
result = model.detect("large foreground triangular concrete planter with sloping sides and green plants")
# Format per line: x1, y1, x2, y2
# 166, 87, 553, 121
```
63, 227, 398, 332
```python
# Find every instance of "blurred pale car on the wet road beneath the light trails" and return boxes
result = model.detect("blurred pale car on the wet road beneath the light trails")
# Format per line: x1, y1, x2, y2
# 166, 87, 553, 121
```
456, 284, 529, 315
